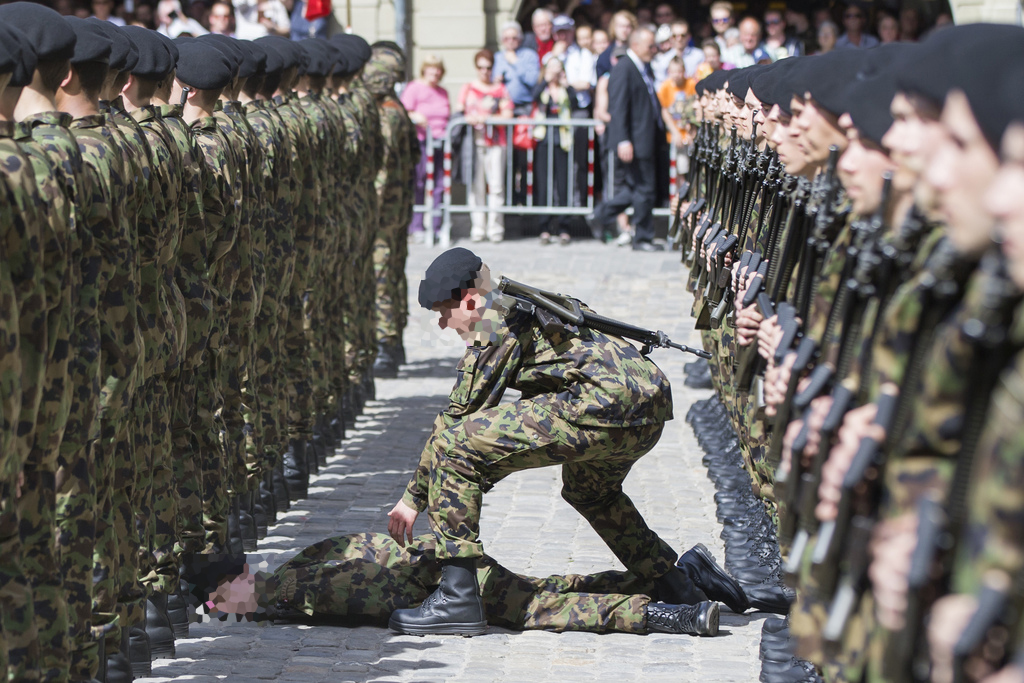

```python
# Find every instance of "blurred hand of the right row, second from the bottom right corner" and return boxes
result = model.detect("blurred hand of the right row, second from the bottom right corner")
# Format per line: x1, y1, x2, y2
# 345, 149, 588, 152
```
867, 512, 918, 631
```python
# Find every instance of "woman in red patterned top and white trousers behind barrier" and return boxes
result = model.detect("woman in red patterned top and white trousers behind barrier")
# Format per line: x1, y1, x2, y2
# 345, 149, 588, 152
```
458, 49, 512, 242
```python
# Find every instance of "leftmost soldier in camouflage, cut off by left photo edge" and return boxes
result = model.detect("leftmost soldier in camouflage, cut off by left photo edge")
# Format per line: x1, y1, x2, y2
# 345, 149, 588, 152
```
0, 26, 49, 674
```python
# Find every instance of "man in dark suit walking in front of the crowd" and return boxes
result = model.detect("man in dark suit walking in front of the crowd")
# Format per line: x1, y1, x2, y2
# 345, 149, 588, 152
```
592, 29, 666, 251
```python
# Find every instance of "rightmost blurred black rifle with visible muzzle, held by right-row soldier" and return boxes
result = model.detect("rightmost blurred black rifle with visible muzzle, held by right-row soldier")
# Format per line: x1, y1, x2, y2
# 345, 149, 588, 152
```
883, 251, 1020, 680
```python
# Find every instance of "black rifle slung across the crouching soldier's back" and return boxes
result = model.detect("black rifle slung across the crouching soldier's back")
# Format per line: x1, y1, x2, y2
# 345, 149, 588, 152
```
498, 278, 712, 358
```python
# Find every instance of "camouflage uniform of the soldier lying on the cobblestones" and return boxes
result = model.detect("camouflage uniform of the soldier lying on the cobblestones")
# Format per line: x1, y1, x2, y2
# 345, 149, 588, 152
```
257, 533, 650, 633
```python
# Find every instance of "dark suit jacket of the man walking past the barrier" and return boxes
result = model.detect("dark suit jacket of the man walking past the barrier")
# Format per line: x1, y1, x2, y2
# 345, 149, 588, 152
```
608, 56, 665, 159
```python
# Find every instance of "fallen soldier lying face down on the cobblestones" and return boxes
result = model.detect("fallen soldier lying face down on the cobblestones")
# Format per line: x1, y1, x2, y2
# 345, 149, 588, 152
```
186, 533, 738, 636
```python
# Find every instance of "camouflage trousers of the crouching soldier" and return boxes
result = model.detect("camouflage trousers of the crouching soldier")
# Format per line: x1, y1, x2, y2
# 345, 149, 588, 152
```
427, 400, 678, 580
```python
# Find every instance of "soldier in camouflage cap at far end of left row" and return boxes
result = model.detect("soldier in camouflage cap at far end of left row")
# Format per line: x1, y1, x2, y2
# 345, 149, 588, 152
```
362, 43, 420, 377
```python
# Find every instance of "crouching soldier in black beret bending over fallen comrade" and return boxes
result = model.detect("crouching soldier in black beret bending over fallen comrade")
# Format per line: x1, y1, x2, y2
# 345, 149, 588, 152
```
388, 249, 745, 634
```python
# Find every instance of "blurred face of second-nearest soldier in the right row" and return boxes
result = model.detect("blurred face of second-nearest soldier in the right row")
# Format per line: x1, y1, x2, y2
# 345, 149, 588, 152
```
923, 90, 999, 256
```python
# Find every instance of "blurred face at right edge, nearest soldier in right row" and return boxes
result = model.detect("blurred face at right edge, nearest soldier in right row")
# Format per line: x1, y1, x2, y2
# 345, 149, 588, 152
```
985, 124, 1024, 289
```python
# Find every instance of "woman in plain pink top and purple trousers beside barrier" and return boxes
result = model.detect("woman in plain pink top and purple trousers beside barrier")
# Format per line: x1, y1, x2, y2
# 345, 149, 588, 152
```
401, 54, 452, 242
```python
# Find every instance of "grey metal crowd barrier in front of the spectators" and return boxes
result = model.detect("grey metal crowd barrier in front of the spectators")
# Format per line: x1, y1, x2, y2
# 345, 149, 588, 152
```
414, 117, 677, 247
